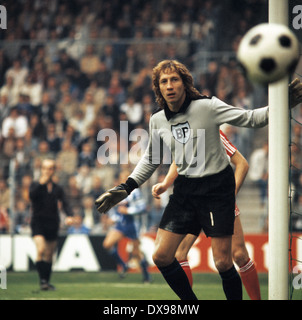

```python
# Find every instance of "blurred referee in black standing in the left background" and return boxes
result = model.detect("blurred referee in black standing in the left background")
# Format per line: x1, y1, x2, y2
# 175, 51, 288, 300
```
30, 159, 73, 290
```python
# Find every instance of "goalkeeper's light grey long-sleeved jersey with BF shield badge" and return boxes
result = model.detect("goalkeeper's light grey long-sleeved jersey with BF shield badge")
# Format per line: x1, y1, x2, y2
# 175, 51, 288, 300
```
130, 96, 268, 186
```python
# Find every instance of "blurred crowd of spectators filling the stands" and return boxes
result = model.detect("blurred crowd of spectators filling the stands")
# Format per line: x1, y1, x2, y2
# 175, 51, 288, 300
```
0, 0, 301, 233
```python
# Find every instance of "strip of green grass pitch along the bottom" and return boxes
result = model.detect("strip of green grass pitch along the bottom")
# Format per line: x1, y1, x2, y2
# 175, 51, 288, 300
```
0, 272, 268, 300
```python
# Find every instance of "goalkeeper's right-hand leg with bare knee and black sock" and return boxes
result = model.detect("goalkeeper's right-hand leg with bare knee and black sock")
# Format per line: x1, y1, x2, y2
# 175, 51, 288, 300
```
212, 236, 242, 300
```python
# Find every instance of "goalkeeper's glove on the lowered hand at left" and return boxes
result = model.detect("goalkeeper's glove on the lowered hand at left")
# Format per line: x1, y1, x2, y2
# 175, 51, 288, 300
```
95, 184, 129, 213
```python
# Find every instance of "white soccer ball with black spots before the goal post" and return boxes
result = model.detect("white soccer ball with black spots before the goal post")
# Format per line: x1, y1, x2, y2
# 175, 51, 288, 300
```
237, 23, 300, 84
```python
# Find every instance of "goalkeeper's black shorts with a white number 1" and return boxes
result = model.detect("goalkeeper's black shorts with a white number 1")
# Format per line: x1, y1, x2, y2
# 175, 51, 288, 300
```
159, 165, 235, 237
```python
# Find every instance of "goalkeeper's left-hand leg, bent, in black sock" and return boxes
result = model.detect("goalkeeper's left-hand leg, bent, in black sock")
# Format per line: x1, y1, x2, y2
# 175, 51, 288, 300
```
153, 228, 197, 300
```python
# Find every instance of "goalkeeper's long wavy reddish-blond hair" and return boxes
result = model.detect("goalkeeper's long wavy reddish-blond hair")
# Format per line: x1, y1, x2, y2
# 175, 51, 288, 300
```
152, 60, 201, 109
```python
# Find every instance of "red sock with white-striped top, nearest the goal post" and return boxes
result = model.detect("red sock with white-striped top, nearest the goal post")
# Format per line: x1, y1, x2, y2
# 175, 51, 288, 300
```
239, 259, 261, 300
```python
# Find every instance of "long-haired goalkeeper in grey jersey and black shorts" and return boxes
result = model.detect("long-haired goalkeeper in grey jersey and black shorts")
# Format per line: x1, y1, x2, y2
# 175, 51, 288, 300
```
96, 60, 302, 300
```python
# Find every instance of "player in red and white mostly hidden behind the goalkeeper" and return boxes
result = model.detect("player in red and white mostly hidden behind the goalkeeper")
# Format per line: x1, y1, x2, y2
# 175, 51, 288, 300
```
152, 130, 261, 300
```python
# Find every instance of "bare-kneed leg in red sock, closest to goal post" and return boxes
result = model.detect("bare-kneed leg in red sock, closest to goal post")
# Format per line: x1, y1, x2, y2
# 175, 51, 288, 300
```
232, 216, 261, 300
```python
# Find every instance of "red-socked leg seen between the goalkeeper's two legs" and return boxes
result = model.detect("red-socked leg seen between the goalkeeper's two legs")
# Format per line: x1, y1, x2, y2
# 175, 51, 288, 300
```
175, 234, 197, 287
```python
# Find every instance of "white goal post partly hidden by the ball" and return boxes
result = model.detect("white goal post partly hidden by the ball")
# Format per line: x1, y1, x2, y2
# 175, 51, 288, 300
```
268, 0, 289, 300
